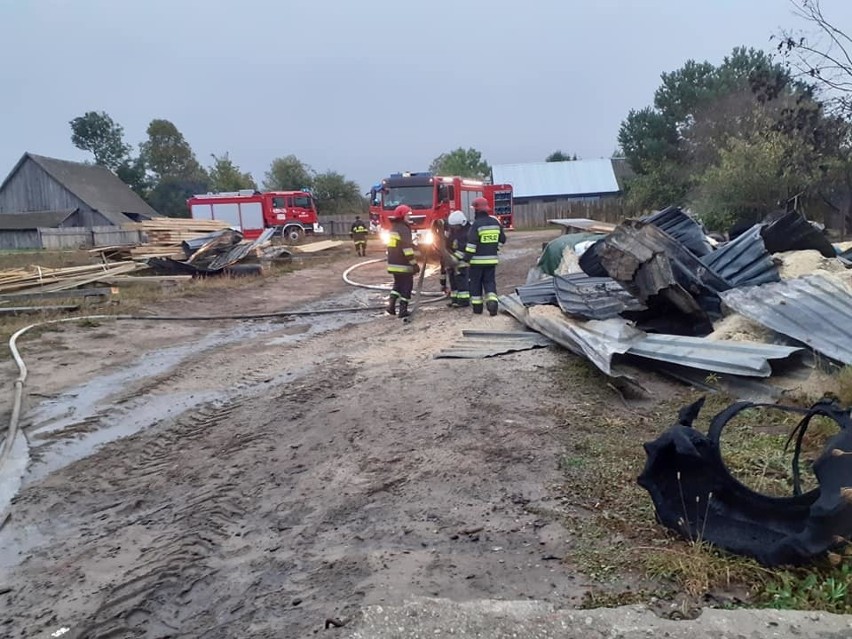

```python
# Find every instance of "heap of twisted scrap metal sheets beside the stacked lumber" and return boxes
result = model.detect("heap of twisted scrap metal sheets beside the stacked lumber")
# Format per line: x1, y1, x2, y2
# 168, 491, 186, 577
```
147, 228, 292, 277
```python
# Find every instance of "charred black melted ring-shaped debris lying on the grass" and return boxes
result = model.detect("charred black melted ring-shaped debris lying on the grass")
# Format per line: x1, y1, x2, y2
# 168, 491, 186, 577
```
639, 399, 852, 566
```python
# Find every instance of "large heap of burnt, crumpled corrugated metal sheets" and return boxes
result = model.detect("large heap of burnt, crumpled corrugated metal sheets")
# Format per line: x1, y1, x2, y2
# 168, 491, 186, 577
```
500, 208, 852, 392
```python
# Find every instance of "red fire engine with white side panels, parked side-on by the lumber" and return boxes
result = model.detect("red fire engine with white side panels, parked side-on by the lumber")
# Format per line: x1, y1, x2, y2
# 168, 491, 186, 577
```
186, 189, 323, 243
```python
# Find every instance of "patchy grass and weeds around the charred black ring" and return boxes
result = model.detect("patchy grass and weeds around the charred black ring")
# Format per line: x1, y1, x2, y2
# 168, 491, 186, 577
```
556, 357, 852, 613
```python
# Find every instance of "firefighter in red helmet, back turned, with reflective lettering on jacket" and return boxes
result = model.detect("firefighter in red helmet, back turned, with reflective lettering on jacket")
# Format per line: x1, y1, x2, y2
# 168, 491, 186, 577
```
464, 197, 506, 316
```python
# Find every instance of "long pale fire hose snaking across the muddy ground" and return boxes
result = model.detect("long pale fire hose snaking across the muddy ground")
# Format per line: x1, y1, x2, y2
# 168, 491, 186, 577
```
0, 259, 444, 472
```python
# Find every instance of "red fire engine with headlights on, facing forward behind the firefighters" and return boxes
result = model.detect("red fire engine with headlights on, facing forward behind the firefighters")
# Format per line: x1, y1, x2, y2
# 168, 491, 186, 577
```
370, 173, 513, 244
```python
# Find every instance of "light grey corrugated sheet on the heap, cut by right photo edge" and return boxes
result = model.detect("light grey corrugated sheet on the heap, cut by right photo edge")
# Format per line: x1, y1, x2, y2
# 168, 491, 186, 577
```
721, 275, 852, 364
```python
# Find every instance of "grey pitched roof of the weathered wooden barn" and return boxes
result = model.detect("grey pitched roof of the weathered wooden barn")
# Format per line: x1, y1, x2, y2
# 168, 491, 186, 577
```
0, 153, 159, 225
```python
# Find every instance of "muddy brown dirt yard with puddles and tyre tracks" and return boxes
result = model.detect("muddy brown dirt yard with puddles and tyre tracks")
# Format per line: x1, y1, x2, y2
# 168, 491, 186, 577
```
0, 232, 684, 638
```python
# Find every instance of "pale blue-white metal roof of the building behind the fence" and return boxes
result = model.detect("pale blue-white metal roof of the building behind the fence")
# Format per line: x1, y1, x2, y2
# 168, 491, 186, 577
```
491, 160, 620, 198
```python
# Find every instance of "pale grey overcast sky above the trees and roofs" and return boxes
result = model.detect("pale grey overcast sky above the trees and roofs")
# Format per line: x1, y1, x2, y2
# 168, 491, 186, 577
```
0, 0, 852, 190
